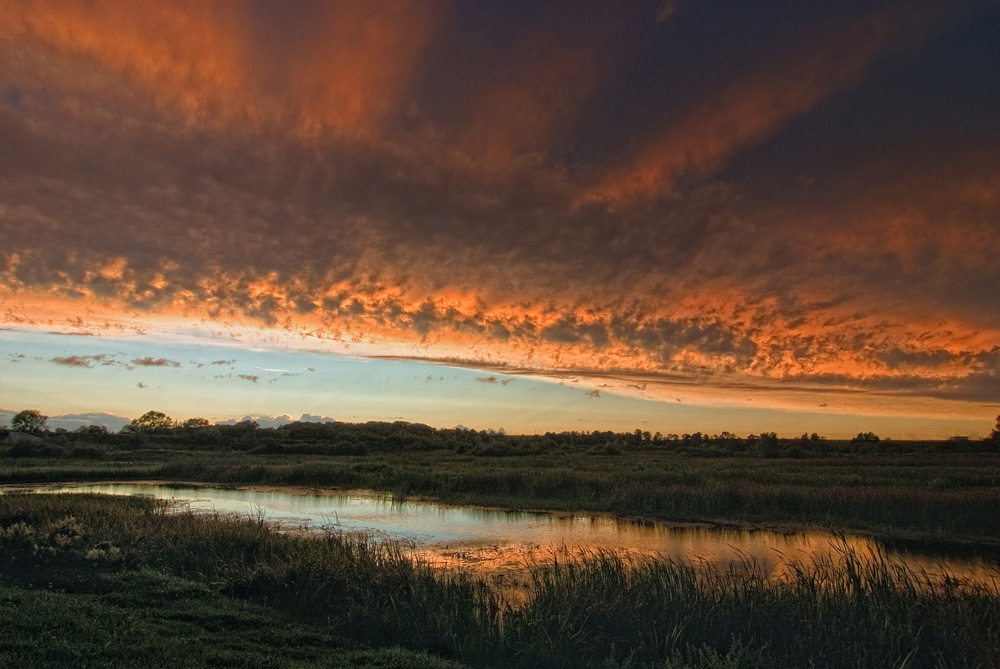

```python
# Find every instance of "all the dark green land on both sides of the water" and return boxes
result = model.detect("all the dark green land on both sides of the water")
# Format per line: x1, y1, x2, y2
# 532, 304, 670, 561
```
0, 423, 1000, 668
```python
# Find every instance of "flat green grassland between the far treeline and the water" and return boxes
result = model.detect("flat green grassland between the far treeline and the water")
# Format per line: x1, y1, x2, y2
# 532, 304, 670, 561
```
7, 440, 1000, 544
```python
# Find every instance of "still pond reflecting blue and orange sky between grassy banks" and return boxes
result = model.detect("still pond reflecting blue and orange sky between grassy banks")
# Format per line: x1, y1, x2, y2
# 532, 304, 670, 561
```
0, 483, 1000, 587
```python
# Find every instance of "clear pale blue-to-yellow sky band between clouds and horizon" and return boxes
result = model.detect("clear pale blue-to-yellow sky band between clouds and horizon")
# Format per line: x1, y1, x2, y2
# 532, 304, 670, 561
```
0, 329, 985, 438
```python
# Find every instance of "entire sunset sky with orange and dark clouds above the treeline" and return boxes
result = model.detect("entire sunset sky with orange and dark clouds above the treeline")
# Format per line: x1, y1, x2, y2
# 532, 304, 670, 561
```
0, 0, 1000, 438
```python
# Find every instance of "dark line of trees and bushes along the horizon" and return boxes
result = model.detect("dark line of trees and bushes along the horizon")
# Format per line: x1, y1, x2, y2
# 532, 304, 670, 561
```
0, 412, 1000, 458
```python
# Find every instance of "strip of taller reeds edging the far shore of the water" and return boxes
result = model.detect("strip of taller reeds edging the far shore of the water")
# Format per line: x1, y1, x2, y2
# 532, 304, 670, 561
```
154, 456, 1000, 539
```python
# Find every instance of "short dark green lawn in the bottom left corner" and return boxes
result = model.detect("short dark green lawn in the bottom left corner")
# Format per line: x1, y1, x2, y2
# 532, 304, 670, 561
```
0, 566, 455, 669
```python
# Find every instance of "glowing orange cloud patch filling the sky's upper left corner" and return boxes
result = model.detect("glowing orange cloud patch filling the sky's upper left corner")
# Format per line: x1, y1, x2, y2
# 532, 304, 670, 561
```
0, 0, 446, 136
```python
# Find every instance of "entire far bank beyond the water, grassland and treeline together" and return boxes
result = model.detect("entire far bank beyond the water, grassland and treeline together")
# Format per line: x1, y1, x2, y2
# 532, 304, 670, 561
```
0, 424, 1000, 543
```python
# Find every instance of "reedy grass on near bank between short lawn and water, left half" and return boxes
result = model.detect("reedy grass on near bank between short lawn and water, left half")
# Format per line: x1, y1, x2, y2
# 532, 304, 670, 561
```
0, 495, 497, 655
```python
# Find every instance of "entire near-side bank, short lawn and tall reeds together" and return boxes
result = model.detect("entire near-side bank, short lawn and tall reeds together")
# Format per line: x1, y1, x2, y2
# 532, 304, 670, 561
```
0, 495, 1000, 668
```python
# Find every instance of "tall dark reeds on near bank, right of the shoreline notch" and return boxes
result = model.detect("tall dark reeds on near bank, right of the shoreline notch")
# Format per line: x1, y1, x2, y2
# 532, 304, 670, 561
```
505, 552, 1000, 667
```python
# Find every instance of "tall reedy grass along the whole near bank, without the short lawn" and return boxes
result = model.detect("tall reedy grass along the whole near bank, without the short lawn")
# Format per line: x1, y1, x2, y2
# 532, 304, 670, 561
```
0, 494, 1000, 668
